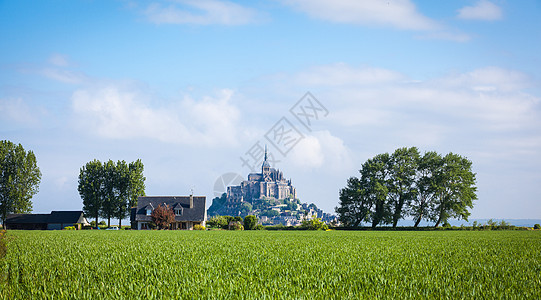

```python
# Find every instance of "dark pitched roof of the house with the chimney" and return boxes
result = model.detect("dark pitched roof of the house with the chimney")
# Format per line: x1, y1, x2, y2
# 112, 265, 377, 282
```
135, 196, 206, 222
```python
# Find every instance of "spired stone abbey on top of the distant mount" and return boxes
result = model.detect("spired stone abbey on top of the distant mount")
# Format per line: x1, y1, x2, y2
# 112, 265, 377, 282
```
227, 149, 297, 206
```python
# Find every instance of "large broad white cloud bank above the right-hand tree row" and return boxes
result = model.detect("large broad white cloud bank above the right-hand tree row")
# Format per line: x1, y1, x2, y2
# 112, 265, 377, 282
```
285, 64, 541, 139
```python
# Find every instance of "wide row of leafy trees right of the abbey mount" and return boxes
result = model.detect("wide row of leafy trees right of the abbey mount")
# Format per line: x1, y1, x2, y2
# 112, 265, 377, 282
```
335, 147, 477, 227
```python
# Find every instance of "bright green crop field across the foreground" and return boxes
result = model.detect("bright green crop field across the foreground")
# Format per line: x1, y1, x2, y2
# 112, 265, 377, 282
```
0, 231, 541, 299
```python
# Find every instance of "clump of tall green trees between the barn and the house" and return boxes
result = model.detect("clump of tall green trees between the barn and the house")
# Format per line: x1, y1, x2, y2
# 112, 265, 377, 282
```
77, 159, 146, 226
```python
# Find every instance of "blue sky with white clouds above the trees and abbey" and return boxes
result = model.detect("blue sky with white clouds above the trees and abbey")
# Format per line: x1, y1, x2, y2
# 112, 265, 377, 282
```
0, 0, 541, 219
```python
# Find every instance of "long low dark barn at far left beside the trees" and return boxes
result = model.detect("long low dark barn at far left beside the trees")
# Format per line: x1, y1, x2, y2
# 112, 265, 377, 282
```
4, 210, 90, 230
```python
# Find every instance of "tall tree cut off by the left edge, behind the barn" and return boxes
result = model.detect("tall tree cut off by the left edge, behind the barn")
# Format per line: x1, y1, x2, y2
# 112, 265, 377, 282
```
0, 140, 41, 224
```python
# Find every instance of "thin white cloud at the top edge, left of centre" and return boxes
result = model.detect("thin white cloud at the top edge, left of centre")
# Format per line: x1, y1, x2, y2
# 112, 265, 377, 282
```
145, 0, 257, 25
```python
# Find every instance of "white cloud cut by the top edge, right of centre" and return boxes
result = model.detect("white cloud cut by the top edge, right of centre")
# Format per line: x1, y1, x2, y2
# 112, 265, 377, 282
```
284, 0, 439, 30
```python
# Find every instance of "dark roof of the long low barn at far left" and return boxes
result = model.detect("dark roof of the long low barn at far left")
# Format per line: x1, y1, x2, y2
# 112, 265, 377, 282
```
6, 210, 85, 224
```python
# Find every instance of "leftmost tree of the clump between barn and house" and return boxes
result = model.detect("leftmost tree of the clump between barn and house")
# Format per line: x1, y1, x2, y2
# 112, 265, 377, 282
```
77, 160, 104, 223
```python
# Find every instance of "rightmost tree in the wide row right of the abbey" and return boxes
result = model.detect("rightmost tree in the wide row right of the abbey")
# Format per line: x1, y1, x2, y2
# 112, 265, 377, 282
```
434, 153, 477, 227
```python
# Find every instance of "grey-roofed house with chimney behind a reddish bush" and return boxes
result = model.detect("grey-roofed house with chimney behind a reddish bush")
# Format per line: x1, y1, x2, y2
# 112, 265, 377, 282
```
130, 196, 207, 230
